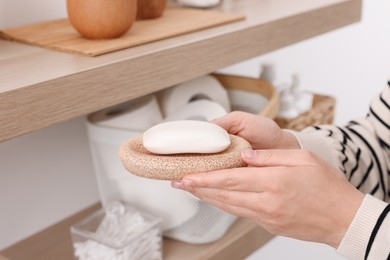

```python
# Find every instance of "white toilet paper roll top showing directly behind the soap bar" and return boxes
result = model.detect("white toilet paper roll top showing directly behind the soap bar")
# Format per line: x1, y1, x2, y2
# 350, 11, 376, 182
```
164, 99, 227, 122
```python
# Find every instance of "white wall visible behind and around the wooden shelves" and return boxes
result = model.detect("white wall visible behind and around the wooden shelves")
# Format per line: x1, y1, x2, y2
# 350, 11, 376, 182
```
0, 0, 390, 259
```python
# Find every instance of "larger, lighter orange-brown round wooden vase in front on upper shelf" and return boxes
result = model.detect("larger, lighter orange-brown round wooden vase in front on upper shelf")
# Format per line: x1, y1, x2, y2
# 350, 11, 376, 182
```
67, 0, 137, 39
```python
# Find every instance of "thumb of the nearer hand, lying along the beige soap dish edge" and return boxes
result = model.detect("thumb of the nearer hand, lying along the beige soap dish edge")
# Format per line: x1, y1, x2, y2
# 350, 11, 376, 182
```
241, 149, 314, 166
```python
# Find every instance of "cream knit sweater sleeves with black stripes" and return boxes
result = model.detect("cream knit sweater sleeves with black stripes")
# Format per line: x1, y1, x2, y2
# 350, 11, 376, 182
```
295, 82, 390, 260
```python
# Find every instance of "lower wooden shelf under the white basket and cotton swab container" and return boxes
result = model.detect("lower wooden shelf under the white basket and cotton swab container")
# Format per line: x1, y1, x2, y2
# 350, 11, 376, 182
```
0, 204, 273, 260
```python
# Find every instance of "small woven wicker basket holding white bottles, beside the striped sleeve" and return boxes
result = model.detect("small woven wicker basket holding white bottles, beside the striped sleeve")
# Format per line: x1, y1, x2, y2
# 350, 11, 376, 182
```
275, 94, 336, 131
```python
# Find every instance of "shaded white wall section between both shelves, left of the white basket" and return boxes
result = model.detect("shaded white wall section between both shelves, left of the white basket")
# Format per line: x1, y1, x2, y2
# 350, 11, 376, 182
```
0, 118, 98, 248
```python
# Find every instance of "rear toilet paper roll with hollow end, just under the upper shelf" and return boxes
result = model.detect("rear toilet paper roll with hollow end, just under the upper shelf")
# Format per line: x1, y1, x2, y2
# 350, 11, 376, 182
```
158, 76, 230, 117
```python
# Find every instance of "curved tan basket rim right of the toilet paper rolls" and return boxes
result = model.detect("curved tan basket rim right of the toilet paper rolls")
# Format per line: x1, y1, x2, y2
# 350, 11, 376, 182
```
211, 73, 279, 119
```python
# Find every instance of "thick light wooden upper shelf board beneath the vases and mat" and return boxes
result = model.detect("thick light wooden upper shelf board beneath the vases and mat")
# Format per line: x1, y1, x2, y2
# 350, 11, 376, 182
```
0, 0, 361, 141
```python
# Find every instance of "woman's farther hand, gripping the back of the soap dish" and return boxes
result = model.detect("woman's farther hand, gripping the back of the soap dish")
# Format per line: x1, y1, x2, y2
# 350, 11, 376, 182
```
212, 111, 300, 149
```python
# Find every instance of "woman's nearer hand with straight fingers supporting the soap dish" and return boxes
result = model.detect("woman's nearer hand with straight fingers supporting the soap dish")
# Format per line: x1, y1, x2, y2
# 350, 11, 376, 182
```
172, 148, 364, 247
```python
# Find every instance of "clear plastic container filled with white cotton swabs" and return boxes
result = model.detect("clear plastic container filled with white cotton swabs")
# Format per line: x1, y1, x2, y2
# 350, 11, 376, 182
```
71, 202, 162, 260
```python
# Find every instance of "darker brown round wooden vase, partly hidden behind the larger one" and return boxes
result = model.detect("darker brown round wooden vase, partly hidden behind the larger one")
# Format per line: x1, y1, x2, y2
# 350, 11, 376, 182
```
137, 0, 167, 19
